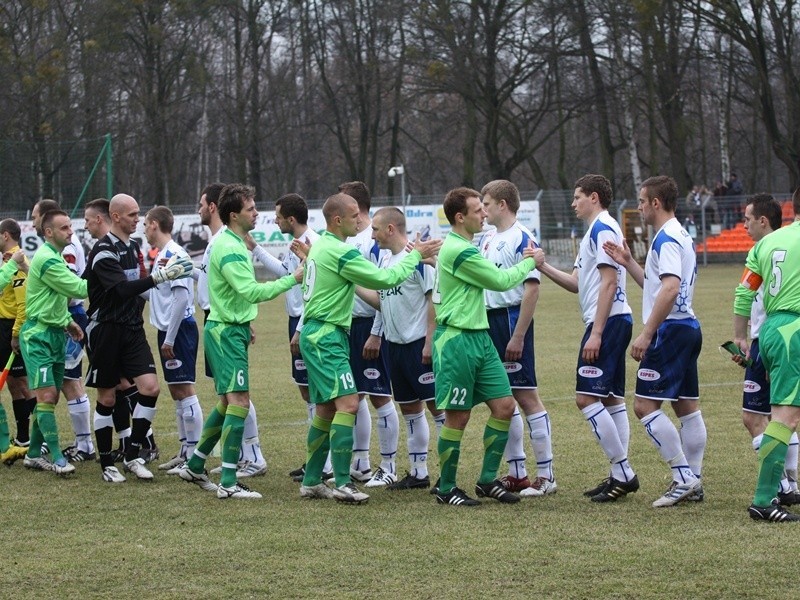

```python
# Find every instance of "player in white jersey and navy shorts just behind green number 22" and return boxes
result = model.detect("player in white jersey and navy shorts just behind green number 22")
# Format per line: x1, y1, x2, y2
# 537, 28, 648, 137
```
478, 179, 558, 496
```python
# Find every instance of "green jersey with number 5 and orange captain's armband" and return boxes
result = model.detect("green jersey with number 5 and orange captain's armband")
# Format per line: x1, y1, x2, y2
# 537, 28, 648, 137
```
733, 222, 800, 317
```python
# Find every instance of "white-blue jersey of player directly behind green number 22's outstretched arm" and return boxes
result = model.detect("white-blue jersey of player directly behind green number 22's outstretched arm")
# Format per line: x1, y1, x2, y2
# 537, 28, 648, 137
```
478, 221, 541, 310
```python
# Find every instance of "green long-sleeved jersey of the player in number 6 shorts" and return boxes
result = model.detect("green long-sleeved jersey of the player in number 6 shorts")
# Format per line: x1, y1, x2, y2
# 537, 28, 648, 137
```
208, 229, 297, 324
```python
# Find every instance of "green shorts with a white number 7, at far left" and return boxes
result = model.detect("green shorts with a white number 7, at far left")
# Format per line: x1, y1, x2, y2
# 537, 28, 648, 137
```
19, 320, 66, 390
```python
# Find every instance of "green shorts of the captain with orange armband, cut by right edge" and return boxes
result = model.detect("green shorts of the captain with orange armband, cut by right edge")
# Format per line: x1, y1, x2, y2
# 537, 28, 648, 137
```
760, 312, 800, 407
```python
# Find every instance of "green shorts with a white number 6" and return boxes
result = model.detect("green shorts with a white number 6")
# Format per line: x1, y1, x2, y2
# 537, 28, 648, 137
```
203, 321, 250, 396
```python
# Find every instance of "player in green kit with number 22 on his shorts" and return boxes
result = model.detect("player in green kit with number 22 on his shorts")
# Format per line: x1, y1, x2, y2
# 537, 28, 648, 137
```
432, 187, 544, 506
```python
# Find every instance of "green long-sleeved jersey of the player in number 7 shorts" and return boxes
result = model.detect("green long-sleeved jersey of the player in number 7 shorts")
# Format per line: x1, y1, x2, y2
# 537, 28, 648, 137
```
25, 242, 88, 327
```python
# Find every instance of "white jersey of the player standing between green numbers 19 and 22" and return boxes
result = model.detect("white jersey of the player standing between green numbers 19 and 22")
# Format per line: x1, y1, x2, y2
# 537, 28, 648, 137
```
378, 249, 436, 344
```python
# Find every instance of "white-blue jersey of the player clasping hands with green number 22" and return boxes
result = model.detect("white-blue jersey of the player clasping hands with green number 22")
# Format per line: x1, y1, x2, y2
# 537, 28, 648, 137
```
575, 210, 632, 325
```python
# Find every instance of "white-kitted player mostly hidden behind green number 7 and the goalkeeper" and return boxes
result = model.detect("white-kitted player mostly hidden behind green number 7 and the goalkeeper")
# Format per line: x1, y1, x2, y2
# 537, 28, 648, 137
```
31, 199, 97, 462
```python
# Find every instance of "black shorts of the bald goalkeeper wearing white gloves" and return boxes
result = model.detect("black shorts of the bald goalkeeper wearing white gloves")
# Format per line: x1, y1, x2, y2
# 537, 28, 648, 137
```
86, 321, 156, 389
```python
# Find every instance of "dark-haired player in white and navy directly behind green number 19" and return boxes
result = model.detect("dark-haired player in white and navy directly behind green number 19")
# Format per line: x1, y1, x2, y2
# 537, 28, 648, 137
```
339, 181, 400, 487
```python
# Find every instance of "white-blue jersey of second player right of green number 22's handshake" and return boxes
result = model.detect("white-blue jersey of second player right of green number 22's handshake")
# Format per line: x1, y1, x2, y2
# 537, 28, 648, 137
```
642, 217, 697, 323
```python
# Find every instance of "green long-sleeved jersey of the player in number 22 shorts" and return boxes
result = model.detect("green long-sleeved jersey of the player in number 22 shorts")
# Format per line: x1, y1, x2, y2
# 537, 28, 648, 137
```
431, 231, 536, 329
